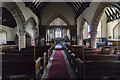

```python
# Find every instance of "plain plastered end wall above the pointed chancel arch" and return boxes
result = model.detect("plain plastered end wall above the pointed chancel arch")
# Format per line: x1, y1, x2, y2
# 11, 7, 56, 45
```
40, 2, 75, 25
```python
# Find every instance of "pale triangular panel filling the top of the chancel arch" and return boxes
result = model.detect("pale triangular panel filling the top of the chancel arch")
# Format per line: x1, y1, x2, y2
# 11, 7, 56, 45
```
49, 17, 67, 26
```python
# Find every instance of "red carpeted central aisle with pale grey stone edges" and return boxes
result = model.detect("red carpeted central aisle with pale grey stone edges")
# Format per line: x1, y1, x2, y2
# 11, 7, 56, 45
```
42, 45, 76, 79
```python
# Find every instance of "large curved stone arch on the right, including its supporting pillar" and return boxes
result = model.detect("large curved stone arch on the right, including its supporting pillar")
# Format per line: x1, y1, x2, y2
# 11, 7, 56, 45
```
90, 2, 114, 48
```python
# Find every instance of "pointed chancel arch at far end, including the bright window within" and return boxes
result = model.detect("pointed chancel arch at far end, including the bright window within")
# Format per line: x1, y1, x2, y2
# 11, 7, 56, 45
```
46, 14, 70, 40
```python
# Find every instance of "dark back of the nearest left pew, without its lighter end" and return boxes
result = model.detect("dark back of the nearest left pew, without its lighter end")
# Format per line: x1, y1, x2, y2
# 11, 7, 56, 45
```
1, 54, 35, 77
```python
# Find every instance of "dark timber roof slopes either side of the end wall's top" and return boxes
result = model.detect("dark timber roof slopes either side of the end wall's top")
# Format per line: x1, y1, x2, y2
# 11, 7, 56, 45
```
23, 0, 90, 18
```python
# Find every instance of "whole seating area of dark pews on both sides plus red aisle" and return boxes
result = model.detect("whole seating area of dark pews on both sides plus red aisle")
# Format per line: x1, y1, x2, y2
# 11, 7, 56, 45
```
2, 43, 120, 80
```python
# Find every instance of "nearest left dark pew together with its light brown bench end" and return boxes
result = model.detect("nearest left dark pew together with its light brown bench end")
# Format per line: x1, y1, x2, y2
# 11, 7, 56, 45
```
2, 54, 43, 78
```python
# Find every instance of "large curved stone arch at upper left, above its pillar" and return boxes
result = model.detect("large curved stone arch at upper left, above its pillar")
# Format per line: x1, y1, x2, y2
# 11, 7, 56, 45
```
2, 2, 25, 33
